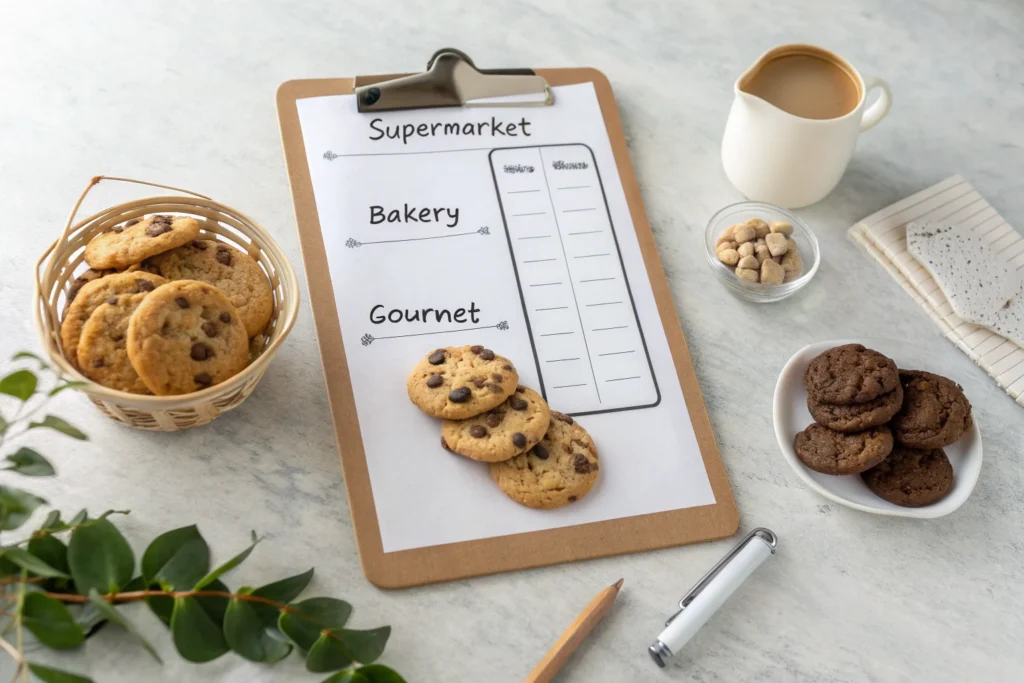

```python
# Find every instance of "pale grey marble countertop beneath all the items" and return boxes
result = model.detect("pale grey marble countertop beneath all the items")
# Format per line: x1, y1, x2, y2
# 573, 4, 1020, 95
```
0, 0, 1024, 683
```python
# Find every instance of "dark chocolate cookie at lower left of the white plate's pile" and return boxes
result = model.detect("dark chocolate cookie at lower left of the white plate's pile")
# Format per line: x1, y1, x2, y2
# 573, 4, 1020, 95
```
794, 424, 893, 475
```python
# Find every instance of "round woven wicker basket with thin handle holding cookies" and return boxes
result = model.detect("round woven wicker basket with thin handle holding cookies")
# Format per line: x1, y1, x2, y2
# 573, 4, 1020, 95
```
34, 176, 299, 431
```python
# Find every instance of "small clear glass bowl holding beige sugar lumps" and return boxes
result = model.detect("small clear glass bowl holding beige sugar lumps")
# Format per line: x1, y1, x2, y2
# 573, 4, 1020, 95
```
705, 202, 821, 303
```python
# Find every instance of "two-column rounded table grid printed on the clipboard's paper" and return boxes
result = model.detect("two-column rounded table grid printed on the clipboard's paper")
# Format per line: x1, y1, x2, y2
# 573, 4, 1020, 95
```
489, 144, 660, 415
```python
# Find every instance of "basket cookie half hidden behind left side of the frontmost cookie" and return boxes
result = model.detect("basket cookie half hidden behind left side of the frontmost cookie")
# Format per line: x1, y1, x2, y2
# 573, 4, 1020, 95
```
78, 292, 152, 394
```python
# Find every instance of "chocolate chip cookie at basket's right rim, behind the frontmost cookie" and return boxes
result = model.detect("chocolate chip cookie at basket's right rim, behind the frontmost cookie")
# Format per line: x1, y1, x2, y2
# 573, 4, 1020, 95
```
142, 240, 273, 337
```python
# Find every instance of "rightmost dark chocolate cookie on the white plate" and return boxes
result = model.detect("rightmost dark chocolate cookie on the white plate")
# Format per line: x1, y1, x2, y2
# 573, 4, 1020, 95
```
892, 370, 972, 449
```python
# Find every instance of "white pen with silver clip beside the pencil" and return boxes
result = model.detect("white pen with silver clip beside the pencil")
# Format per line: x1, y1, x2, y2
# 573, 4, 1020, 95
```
647, 527, 778, 667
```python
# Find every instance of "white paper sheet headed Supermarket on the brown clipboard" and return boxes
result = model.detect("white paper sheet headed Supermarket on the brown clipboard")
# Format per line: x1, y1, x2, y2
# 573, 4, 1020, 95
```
298, 84, 715, 552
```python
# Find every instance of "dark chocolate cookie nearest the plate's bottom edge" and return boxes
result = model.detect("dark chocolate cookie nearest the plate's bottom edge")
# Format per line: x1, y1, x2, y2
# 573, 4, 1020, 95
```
860, 445, 953, 508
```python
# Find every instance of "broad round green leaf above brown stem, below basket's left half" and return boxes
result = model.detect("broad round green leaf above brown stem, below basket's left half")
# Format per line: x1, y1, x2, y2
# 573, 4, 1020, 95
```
68, 519, 135, 595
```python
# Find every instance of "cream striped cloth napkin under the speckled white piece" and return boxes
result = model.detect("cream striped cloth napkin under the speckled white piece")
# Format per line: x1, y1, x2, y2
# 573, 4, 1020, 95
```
849, 175, 1024, 407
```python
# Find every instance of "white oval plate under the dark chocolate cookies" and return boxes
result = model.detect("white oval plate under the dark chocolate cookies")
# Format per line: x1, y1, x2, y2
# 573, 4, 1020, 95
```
774, 339, 981, 519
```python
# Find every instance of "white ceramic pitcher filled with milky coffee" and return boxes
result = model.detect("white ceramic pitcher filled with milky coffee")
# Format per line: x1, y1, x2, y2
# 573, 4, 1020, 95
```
722, 45, 892, 209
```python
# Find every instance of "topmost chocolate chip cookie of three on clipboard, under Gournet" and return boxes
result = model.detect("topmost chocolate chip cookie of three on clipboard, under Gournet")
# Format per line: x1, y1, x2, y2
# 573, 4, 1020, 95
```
406, 345, 519, 420
